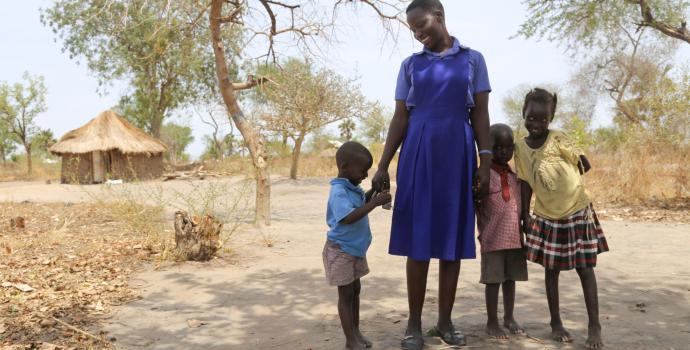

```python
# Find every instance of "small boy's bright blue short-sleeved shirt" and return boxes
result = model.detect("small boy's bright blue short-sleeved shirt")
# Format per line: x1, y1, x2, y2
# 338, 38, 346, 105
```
326, 178, 371, 258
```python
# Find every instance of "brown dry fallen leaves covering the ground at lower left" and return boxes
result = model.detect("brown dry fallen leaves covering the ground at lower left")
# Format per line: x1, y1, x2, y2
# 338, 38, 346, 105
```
0, 203, 159, 349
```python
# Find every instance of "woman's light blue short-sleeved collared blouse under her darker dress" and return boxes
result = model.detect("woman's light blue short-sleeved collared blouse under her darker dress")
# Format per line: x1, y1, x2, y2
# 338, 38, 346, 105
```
395, 38, 491, 109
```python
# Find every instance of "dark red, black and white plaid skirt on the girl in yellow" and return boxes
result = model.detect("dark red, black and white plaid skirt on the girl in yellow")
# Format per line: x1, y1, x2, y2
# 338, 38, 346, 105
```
525, 205, 609, 270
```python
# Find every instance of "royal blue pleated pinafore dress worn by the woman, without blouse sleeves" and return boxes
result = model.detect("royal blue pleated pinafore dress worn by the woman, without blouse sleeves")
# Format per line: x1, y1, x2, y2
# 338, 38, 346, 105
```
389, 47, 478, 261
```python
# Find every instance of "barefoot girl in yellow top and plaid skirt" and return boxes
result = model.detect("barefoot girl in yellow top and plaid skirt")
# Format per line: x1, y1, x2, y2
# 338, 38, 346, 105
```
515, 88, 608, 349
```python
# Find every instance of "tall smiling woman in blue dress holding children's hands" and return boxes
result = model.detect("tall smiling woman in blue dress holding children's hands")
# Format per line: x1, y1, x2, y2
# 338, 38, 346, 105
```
372, 0, 491, 349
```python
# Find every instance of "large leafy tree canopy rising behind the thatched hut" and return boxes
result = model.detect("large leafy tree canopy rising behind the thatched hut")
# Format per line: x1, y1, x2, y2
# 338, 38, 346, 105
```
41, 0, 232, 137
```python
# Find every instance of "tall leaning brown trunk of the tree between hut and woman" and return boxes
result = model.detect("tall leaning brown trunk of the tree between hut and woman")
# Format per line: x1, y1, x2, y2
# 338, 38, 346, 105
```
209, 0, 271, 226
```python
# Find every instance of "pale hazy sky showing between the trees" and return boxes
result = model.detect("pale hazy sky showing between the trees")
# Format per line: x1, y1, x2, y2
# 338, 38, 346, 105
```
0, 0, 690, 156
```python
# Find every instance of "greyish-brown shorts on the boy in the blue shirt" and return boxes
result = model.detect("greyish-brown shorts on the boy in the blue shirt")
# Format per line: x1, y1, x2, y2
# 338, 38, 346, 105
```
323, 241, 369, 286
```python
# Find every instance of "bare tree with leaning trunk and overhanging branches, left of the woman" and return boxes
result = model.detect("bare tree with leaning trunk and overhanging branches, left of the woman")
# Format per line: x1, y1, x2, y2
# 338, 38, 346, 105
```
209, 0, 404, 225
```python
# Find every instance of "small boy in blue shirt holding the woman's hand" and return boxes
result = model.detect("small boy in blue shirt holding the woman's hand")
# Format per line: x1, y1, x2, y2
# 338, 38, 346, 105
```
323, 141, 391, 349
